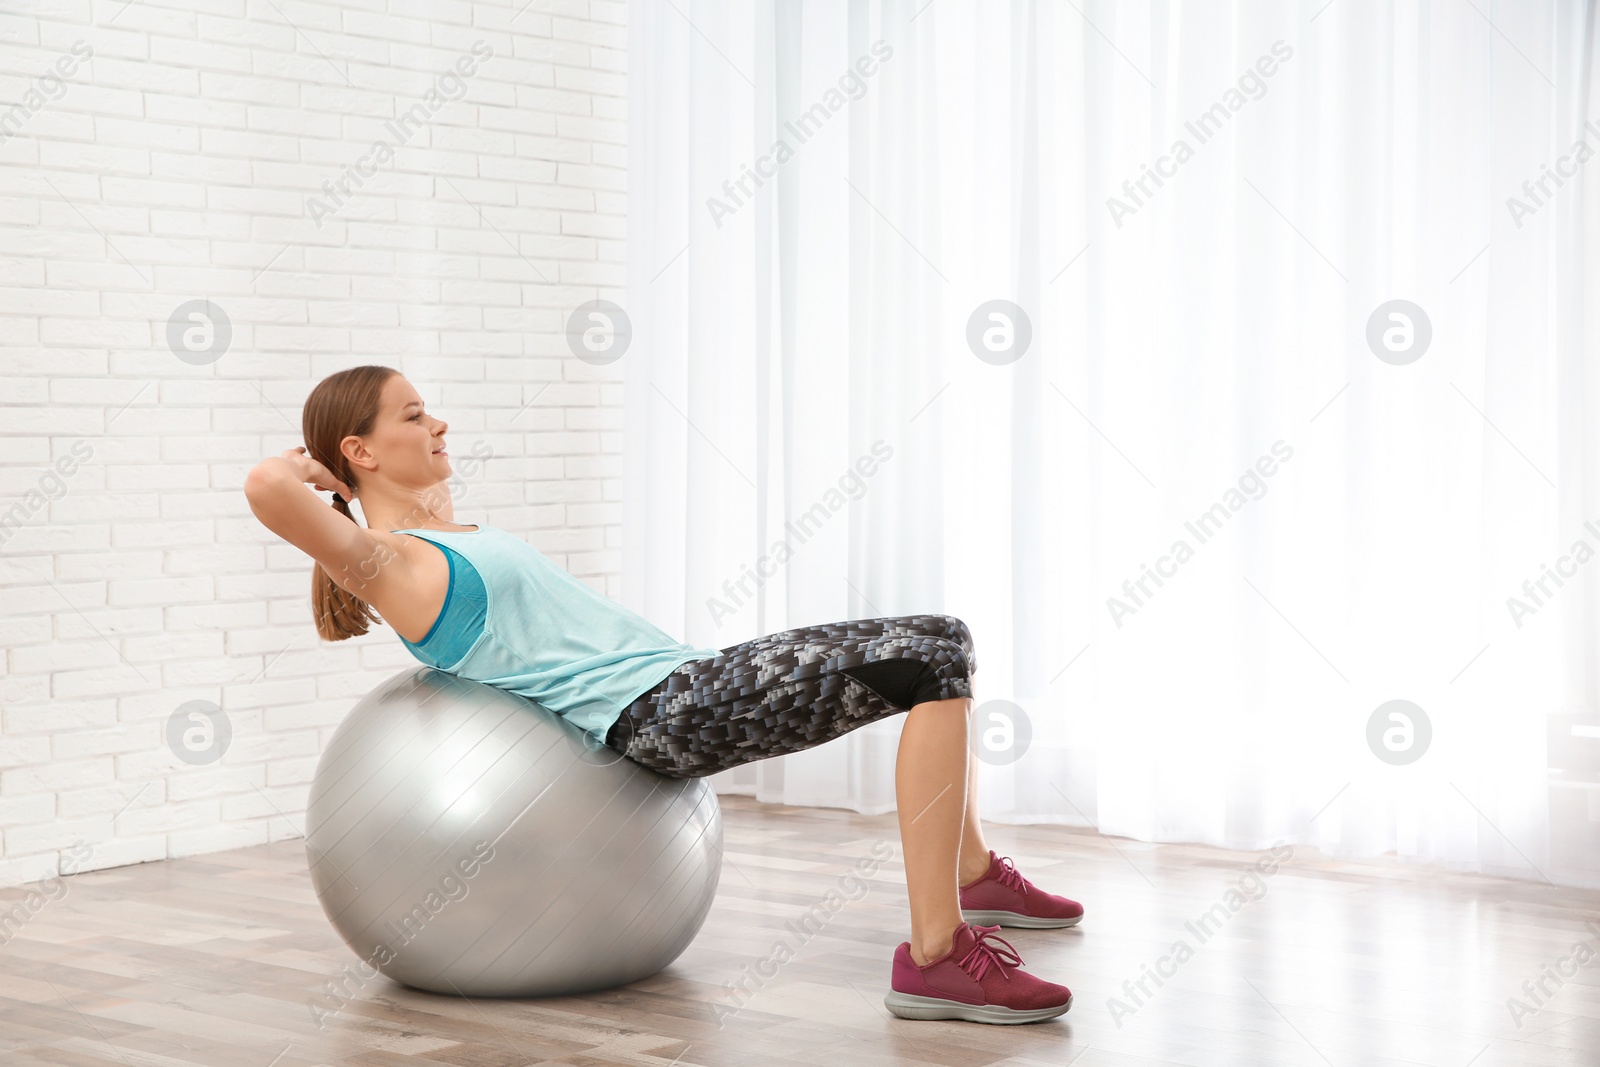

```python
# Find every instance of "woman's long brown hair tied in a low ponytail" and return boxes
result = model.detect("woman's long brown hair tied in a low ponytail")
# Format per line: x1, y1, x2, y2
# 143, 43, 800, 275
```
301, 365, 400, 641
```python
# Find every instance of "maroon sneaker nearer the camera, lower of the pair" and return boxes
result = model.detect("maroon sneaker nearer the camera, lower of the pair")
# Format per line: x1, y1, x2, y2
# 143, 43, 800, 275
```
883, 923, 1072, 1022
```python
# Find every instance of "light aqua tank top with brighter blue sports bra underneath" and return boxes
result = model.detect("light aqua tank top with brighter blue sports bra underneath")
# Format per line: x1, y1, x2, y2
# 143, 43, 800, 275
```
390, 525, 722, 744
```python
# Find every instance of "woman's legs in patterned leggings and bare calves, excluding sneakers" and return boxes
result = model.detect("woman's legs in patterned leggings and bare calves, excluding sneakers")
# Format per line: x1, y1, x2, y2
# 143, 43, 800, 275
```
606, 614, 989, 963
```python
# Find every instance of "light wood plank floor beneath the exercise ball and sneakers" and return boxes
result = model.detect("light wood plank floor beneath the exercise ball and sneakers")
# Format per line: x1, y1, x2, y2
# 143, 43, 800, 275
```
0, 797, 1600, 1067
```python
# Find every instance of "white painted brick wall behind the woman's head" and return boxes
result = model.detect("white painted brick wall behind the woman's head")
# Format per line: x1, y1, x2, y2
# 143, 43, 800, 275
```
0, 0, 627, 886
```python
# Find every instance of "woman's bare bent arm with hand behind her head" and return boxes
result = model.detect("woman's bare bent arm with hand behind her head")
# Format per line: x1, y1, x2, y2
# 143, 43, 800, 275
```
245, 448, 402, 603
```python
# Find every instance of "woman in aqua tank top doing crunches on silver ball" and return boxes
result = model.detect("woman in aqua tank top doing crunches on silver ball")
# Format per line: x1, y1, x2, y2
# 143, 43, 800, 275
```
245, 366, 1083, 1022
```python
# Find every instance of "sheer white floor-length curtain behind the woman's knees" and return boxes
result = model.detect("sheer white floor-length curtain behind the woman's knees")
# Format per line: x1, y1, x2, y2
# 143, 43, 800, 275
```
622, 0, 1600, 885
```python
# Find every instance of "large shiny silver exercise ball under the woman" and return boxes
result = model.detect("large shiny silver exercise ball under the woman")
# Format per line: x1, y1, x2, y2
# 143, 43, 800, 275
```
306, 667, 722, 997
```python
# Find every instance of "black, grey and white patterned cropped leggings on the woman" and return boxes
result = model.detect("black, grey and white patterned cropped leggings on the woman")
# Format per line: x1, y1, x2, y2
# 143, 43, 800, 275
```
605, 614, 978, 777
